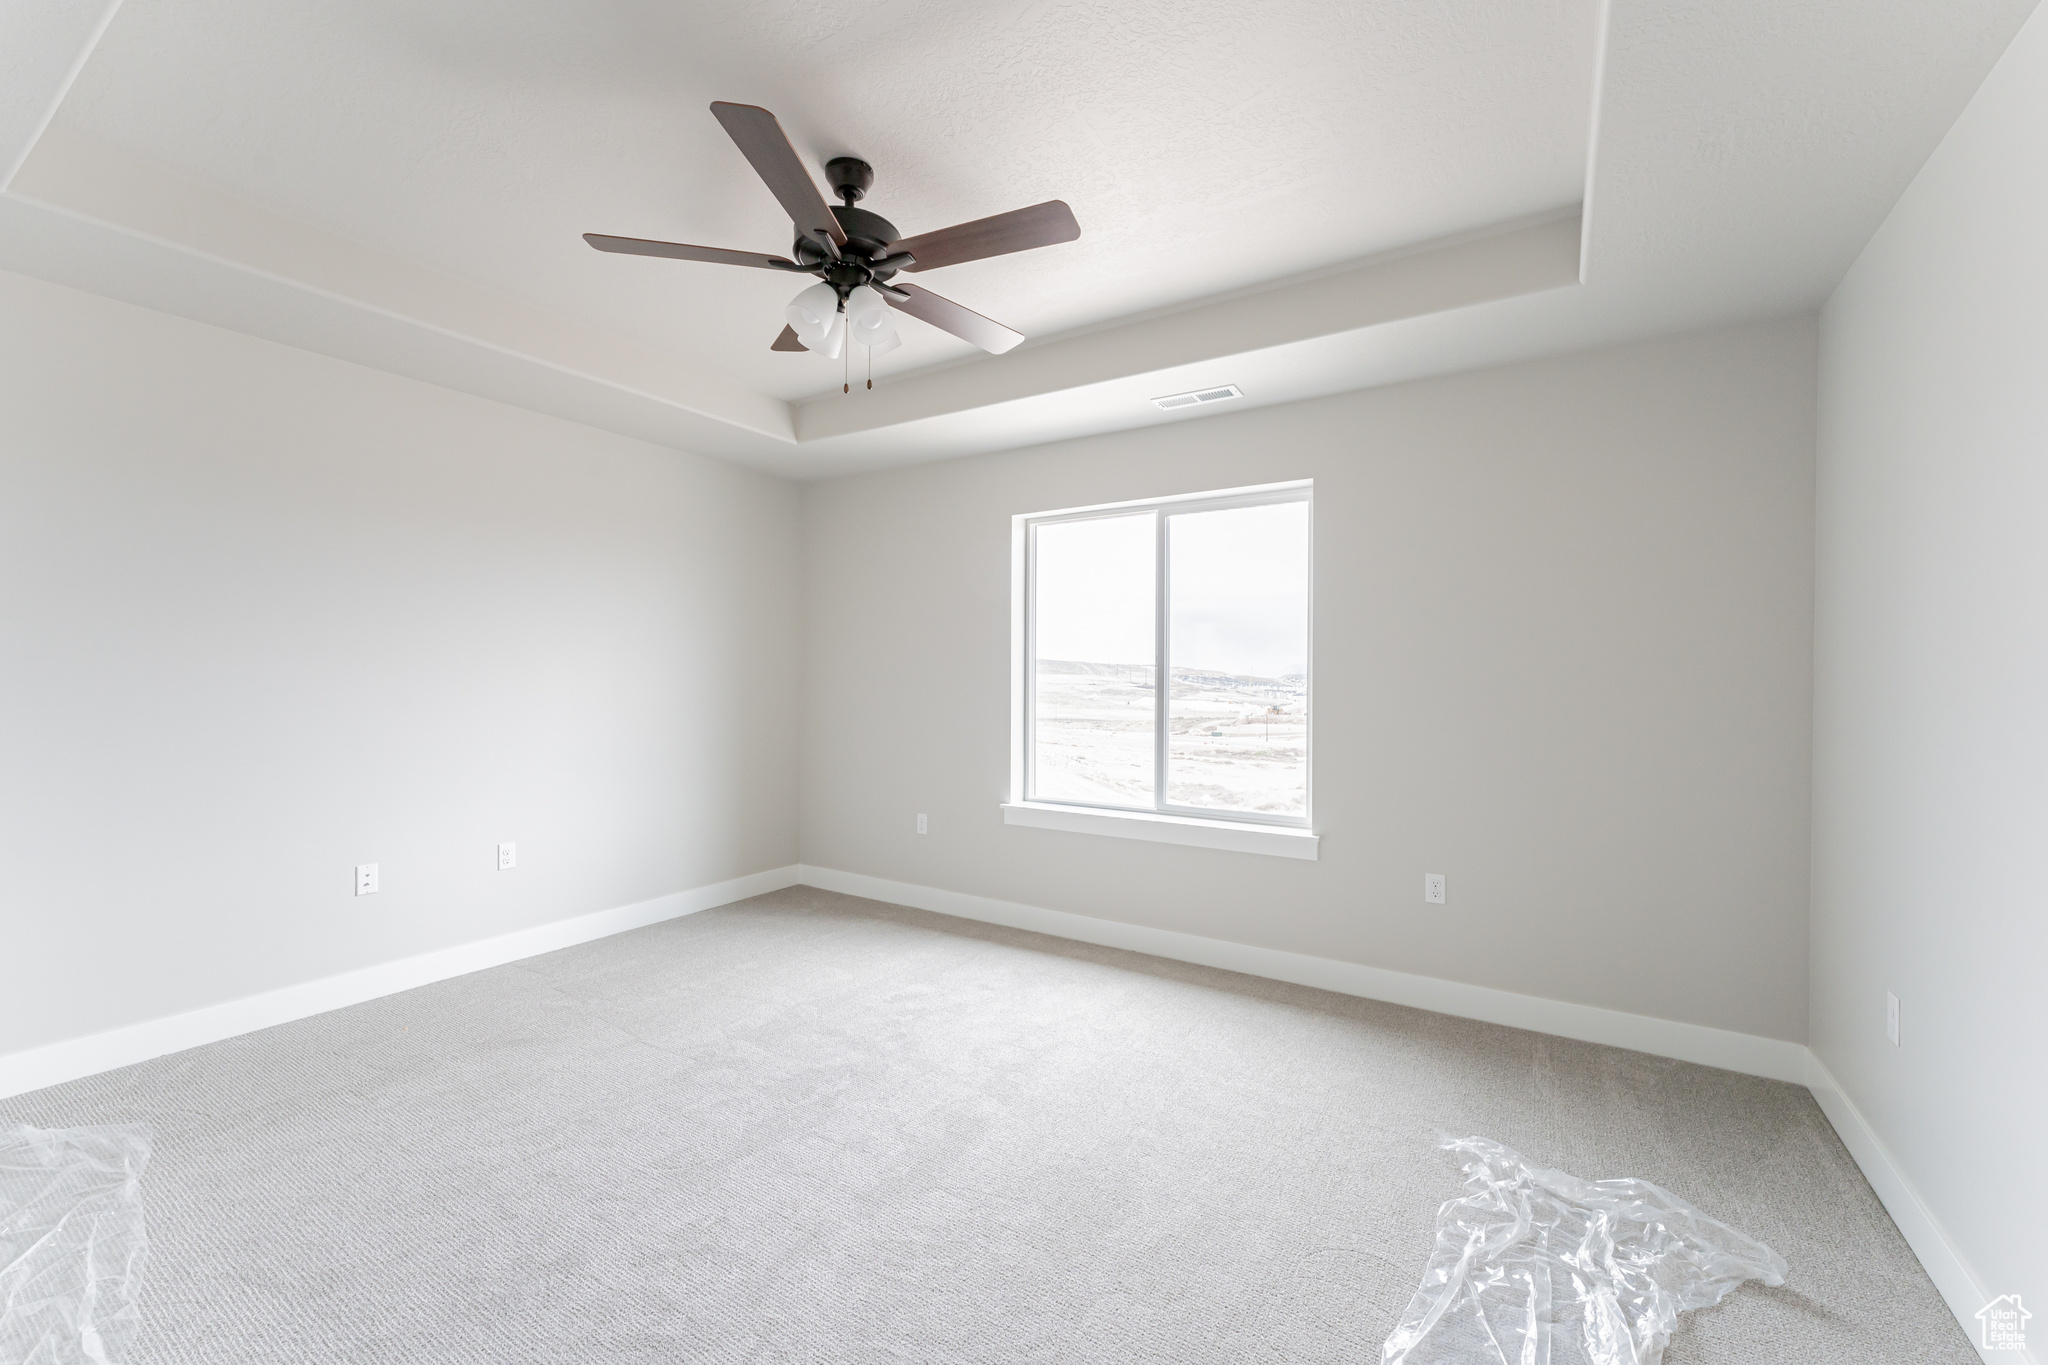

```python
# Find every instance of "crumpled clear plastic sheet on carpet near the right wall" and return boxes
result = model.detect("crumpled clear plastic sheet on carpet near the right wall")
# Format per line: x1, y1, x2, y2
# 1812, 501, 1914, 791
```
1380, 1138, 1786, 1365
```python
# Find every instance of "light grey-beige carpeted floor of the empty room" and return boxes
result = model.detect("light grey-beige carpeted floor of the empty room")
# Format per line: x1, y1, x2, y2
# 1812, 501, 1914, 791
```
0, 888, 1976, 1365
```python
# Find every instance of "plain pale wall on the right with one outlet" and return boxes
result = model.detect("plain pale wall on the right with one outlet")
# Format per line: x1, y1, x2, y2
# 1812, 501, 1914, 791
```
1810, 0, 2048, 1326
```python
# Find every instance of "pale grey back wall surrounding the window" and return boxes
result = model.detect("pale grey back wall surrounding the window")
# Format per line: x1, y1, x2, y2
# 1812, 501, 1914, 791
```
803, 319, 1815, 1040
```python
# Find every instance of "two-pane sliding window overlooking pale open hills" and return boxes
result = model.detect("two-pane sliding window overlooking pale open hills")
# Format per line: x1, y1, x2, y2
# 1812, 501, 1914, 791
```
1012, 474, 1313, 855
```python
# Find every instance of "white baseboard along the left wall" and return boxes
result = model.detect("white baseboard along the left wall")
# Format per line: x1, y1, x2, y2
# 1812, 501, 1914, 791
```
0, 866, 799, 1099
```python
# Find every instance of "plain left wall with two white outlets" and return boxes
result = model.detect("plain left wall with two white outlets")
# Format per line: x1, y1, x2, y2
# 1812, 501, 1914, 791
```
0, 274, 799, 1054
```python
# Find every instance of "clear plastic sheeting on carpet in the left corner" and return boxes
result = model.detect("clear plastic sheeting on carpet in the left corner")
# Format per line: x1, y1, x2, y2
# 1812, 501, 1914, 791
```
0, 1124, 150, 1365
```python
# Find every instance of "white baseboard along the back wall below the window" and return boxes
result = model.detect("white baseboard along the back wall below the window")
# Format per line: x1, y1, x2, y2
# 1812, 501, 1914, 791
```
799, 866, 1806, 1085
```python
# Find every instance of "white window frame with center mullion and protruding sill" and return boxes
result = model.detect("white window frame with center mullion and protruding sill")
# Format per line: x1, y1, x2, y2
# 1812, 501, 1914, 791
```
1004, 479, 1319, 857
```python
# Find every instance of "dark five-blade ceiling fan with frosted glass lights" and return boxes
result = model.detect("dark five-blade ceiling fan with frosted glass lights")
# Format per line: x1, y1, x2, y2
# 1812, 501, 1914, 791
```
584, 100, 1081, 360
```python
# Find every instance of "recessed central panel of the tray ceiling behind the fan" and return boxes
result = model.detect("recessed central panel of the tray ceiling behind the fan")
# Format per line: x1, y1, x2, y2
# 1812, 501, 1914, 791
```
57, 0, 1597, 397
